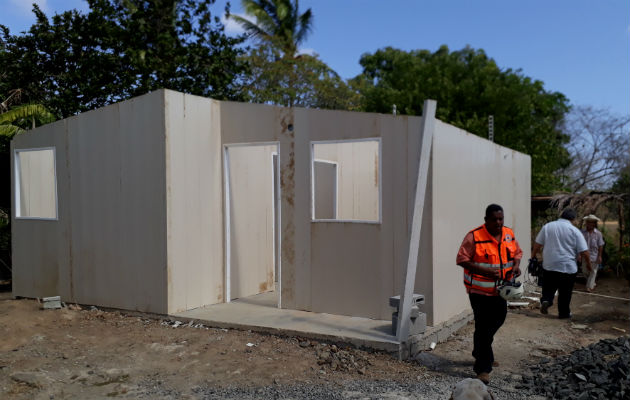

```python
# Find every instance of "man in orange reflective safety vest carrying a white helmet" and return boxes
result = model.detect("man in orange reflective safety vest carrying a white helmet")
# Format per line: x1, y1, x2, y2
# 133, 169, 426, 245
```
457, 204, 523, 384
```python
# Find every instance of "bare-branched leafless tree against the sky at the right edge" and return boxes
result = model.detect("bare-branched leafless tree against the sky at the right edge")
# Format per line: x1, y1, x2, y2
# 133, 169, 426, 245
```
563, 106, 630, 193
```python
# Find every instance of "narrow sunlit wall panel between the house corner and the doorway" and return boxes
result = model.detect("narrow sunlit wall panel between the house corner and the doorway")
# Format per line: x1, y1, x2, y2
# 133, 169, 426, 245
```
165, 91, 224, 312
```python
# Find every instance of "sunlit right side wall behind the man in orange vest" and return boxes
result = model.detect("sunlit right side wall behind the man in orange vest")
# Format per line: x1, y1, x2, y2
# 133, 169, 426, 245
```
432, 120, 531, 323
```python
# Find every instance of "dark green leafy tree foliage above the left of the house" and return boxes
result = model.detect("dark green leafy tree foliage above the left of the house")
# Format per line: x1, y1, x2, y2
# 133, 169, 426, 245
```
0, 0, 244, 117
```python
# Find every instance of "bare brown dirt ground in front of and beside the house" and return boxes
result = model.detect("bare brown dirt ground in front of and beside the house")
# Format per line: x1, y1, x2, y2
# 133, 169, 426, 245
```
0, 277, 630, 399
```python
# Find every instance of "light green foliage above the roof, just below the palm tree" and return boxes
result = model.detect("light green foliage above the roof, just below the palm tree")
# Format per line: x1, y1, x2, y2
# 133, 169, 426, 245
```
244, 44, 358, 110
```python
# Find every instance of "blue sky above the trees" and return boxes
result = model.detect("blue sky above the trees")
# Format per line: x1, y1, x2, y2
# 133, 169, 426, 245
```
0, 0, 630, 115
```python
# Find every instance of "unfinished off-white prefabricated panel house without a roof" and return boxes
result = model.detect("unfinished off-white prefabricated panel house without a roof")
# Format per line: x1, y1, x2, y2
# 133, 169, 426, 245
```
11, 90, 530, 342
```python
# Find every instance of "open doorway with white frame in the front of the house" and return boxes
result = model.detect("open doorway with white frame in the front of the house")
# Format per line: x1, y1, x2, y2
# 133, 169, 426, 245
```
224, 143, 280, 307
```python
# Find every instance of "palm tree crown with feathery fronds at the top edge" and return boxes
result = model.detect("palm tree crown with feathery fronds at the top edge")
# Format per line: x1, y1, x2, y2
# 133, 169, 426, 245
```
230, 0, 313, 58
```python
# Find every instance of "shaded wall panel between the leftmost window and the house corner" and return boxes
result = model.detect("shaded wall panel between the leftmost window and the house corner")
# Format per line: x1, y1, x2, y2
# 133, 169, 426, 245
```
64, 91, 167, 313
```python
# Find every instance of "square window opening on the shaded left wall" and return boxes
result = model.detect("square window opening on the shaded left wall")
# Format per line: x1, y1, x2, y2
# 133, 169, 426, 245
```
14, 148, 57, 219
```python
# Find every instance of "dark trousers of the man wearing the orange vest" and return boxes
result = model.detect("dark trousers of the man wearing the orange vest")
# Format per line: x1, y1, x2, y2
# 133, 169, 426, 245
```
468, 293, 507, 374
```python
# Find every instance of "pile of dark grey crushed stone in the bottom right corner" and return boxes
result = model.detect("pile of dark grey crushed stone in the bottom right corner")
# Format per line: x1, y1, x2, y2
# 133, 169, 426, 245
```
520, 336, 630, 400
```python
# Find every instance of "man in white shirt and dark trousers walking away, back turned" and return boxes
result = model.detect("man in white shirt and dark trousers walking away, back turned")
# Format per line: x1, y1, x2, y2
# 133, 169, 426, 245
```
532, 208, 593, 318
